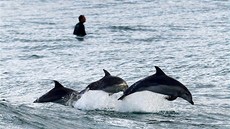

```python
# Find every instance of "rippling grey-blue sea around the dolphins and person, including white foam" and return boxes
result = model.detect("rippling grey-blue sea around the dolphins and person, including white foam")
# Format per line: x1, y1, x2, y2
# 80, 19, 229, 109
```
0, 0, 230, 129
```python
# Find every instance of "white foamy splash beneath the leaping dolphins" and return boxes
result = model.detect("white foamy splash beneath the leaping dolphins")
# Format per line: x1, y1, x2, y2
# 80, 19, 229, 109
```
74, 91, 172, 112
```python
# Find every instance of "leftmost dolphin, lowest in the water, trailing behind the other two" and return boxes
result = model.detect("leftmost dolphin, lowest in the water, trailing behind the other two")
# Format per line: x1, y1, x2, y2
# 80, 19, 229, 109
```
34, 80, 81, 106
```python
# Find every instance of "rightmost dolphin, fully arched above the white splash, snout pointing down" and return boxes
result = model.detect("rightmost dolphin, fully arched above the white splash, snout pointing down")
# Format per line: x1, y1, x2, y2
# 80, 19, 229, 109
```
118, 66, 194, 105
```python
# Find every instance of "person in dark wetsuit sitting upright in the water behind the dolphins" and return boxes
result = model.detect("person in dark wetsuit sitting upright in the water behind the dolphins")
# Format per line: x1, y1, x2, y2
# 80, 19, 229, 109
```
73, 15, 86, 36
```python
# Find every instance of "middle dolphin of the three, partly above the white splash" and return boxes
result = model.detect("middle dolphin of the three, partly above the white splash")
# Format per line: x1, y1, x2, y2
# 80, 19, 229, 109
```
80, 69, 128, 95
